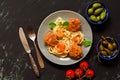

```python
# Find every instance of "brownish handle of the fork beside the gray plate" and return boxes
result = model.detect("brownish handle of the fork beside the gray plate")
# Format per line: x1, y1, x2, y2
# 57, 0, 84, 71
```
34, 41, 45, 68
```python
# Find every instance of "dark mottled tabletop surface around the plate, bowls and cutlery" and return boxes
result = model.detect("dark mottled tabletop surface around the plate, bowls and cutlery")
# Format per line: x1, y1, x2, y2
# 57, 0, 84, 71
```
0, 0, 120, 80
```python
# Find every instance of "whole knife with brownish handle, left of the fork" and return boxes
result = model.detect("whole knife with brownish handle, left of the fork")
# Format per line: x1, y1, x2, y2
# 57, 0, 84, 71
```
19, 27, 40, 77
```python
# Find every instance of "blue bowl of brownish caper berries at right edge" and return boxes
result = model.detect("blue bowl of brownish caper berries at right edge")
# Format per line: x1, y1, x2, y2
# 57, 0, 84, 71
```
96, 36, 120, 62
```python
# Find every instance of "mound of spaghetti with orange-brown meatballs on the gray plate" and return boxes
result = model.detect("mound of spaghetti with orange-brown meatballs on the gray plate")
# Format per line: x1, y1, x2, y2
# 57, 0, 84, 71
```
44, 17, 85, 59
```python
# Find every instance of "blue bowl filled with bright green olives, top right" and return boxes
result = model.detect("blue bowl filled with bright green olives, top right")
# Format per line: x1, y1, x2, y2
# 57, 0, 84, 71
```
85, 2, 109, 25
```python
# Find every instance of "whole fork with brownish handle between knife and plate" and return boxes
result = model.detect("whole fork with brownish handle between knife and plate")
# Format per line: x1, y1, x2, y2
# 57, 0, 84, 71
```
27, 27, 44, 68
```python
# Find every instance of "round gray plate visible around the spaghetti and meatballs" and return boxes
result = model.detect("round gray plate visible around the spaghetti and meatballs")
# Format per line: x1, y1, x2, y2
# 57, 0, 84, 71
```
37, 10, 93, 65
